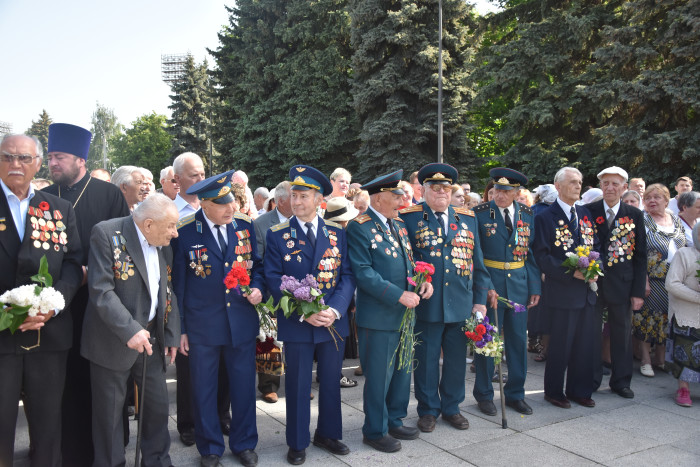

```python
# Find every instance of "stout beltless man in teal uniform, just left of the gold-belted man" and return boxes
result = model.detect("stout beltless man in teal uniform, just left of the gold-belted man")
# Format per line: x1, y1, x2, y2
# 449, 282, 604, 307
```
401, 164, 489, 432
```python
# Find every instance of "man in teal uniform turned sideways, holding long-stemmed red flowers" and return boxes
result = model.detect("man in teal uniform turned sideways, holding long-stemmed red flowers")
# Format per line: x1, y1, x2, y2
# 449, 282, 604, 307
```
347, 170, 433, 452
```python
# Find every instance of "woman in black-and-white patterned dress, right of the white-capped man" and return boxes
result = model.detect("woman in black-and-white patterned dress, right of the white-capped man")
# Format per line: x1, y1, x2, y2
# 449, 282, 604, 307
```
632, 183, 685, 377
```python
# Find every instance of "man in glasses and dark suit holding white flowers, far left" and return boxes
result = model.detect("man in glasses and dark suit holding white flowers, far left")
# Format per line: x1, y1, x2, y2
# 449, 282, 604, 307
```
0, 135, 82, 467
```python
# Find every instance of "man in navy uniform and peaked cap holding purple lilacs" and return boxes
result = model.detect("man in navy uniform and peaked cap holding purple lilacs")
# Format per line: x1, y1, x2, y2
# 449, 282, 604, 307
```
264, 165, 355, 465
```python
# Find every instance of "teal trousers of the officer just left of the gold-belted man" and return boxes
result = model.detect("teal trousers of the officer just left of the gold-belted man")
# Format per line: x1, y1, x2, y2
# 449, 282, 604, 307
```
413, 321, 467, 417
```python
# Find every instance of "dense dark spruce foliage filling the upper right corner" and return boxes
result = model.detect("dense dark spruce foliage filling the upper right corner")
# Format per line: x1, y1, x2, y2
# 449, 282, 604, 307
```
470, 0, 700, 183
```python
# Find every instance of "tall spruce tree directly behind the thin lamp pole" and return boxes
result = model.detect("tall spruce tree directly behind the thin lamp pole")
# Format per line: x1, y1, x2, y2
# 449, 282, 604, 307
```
350, 0, 476, 178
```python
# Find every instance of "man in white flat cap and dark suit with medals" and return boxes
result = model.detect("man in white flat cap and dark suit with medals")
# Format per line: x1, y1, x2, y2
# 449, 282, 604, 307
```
586, 166, 647, 399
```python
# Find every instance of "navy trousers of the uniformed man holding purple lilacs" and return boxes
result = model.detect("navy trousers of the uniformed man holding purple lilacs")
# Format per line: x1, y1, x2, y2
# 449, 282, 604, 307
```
284, 339, 345, 451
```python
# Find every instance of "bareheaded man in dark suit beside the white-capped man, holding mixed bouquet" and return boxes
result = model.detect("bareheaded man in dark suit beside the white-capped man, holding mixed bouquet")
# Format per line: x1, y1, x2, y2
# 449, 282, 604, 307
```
532, 167, 600, 409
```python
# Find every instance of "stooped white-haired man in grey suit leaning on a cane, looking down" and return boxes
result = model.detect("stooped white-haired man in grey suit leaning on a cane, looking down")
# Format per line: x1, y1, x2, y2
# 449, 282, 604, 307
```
81, 193, 180, 466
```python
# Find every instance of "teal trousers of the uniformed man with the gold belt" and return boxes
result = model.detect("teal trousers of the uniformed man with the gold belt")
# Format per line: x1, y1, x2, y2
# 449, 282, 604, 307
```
473, 303, 528, 402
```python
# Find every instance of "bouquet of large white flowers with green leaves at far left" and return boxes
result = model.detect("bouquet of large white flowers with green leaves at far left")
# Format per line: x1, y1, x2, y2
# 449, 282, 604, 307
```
0, 255, 66, 338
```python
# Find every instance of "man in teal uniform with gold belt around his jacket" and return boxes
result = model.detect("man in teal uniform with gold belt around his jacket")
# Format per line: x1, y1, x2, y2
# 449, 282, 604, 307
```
473, 167, 541, 415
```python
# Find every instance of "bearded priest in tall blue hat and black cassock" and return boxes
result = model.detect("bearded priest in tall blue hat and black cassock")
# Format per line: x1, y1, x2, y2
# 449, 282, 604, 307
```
43, 123, 129, 467
